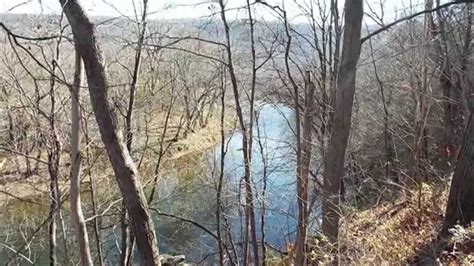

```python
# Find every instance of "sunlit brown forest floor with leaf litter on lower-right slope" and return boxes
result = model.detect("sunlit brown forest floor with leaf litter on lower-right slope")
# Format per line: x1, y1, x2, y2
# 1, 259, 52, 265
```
341, 183, 474, 265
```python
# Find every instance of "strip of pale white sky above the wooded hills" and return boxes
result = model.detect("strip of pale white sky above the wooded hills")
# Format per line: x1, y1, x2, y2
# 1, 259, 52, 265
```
0, 0, 423, 22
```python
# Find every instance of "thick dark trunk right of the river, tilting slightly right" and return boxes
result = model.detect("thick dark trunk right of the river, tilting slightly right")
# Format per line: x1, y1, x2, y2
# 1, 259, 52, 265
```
322, 0, 363, 244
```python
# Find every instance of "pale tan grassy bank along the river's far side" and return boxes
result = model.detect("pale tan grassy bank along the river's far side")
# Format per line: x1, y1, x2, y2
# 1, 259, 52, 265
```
0, 114, 233, 206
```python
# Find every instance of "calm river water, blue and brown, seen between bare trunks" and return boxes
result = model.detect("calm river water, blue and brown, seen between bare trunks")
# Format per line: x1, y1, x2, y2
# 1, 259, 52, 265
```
0, 104, 297, 265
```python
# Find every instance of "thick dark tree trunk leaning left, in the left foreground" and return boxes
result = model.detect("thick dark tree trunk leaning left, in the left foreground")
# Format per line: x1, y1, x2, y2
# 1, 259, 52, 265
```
60, 0, 160, 265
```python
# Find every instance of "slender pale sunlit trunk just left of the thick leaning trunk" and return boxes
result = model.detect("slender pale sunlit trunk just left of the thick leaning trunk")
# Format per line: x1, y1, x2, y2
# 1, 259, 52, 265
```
71, 40, 92, 266
